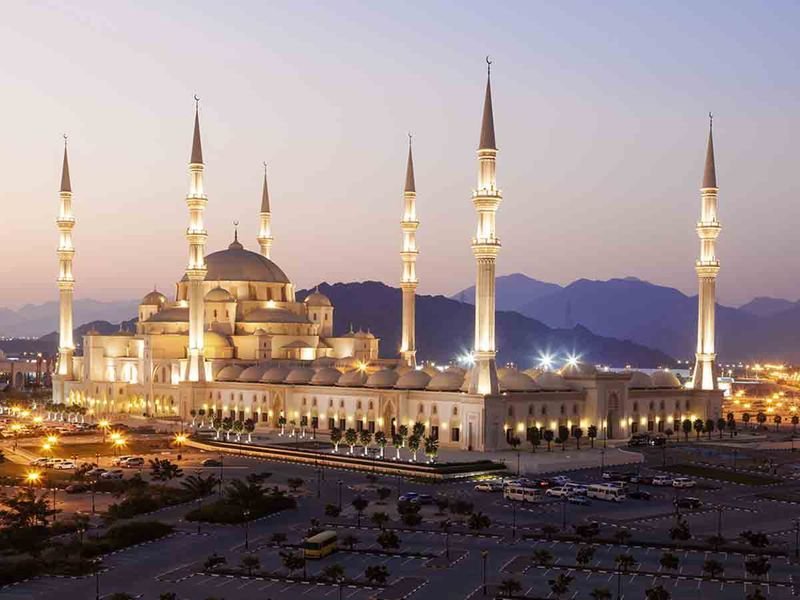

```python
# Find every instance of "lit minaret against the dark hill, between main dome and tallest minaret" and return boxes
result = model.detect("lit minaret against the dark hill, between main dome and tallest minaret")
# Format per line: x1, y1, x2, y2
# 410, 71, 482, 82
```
400, 133, 419, 367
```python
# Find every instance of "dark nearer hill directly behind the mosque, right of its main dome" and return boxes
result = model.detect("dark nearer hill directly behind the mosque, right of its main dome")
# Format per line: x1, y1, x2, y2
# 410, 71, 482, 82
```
297, 281, 675, 368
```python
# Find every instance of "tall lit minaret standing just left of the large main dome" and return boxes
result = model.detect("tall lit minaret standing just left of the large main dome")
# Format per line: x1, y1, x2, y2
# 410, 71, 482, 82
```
186, 96, 208, 381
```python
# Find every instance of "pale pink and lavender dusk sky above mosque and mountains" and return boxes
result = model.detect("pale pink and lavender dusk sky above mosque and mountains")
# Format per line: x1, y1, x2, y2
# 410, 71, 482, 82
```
0, 0, 800, 307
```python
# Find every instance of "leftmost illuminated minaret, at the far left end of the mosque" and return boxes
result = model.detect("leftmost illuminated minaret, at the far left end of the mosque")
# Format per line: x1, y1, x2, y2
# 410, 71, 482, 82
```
56, 135, 75, 379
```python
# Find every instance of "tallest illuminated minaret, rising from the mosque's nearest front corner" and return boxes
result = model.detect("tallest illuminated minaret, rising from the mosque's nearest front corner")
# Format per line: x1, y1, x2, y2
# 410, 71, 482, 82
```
469, 56, 503, 395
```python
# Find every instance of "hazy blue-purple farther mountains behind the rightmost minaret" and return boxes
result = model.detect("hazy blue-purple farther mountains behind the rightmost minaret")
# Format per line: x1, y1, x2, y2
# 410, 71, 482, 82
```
453, 274, 800, 362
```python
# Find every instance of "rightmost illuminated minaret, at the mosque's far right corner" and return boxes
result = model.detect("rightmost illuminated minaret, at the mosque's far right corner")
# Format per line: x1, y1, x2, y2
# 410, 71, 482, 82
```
692, 113, 721, 390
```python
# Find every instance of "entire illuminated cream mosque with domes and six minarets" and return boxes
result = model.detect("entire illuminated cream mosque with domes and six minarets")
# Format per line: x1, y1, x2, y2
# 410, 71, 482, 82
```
53, 65, 722, 451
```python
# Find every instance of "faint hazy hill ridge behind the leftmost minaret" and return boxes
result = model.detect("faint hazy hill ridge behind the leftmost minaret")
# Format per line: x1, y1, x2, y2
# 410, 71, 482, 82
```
0, 298, 138, 337
